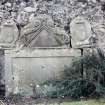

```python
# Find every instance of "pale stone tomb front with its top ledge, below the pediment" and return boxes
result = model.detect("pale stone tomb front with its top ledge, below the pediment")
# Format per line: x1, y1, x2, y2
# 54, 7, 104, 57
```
5, 49, 81, 95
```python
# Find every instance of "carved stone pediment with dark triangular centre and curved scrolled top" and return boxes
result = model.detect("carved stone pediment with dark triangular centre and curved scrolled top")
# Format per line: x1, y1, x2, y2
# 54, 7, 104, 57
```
20, 16, 69, 47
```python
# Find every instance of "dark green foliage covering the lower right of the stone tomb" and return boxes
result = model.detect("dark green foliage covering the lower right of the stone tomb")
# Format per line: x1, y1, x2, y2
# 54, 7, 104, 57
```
41, 49, 105, 98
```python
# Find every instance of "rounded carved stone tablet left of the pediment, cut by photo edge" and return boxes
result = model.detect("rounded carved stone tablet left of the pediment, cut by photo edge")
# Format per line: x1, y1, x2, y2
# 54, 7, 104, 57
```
0, 19, 18, 47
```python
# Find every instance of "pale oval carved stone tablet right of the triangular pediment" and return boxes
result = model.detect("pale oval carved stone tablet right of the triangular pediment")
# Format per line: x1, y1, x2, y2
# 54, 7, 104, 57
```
71, 17, 91, 48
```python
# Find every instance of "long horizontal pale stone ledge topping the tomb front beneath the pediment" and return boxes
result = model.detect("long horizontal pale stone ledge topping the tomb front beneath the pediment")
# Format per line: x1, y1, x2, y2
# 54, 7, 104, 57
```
5, 48, 81, 58
